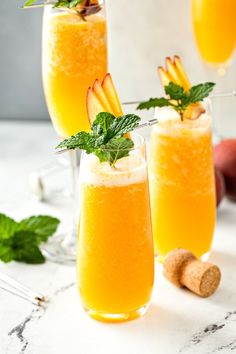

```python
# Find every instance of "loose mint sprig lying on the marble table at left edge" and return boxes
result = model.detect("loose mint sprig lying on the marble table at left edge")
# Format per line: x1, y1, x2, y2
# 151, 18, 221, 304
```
0, 214, 60, 264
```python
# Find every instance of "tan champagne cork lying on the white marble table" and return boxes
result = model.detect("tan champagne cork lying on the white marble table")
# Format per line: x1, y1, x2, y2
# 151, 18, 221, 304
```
163, 248, 221, 297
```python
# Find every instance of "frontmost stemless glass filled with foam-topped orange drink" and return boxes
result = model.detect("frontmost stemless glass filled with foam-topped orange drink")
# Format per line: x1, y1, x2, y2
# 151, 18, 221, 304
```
77, 134, 154, 322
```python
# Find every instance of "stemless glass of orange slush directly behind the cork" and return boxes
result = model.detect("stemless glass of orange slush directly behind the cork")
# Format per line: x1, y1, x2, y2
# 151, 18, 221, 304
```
150, 101, 216, 261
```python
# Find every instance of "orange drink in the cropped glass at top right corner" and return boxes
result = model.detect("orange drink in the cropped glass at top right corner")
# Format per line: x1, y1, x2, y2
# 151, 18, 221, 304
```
192, 0, 236, 64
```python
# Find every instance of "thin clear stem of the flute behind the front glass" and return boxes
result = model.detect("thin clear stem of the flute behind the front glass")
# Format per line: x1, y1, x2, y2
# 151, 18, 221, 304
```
63, 150, 80, 251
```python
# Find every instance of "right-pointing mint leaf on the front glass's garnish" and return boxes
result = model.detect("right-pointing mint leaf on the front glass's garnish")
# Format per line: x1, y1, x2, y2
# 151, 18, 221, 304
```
105, 114, 141, 141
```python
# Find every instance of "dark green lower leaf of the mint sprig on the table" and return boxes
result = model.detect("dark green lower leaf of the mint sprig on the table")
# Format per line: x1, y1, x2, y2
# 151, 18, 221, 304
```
12, 231, 45, 264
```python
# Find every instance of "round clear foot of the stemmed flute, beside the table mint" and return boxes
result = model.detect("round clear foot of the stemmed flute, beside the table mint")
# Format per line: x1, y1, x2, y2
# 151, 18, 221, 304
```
41, 234, 77, 265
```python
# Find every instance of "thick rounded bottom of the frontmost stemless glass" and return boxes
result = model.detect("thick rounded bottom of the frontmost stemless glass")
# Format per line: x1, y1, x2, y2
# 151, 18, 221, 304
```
84, 304, 149, 323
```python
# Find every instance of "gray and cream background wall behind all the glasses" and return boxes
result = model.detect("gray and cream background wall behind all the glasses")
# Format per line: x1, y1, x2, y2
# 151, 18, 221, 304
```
0, 0, 236, 134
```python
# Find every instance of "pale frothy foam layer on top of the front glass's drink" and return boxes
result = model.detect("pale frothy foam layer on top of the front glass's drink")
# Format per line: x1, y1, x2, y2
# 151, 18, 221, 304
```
80, 154, 147, 187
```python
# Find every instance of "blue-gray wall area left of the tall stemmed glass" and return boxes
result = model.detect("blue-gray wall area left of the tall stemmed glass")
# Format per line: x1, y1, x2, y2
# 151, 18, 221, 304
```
0, 0, 47, 119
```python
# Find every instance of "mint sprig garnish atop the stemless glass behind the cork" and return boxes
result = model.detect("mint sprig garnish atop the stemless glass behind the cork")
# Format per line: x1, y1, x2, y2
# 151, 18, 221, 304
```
137, 82, 215, 119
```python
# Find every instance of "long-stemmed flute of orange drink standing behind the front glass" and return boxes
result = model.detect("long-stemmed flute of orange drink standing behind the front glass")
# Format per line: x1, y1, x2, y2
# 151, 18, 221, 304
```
43, 2, 107, 262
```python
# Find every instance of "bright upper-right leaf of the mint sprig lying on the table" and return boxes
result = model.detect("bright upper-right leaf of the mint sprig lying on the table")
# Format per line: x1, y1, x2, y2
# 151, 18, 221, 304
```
17, 215, 60, 244
